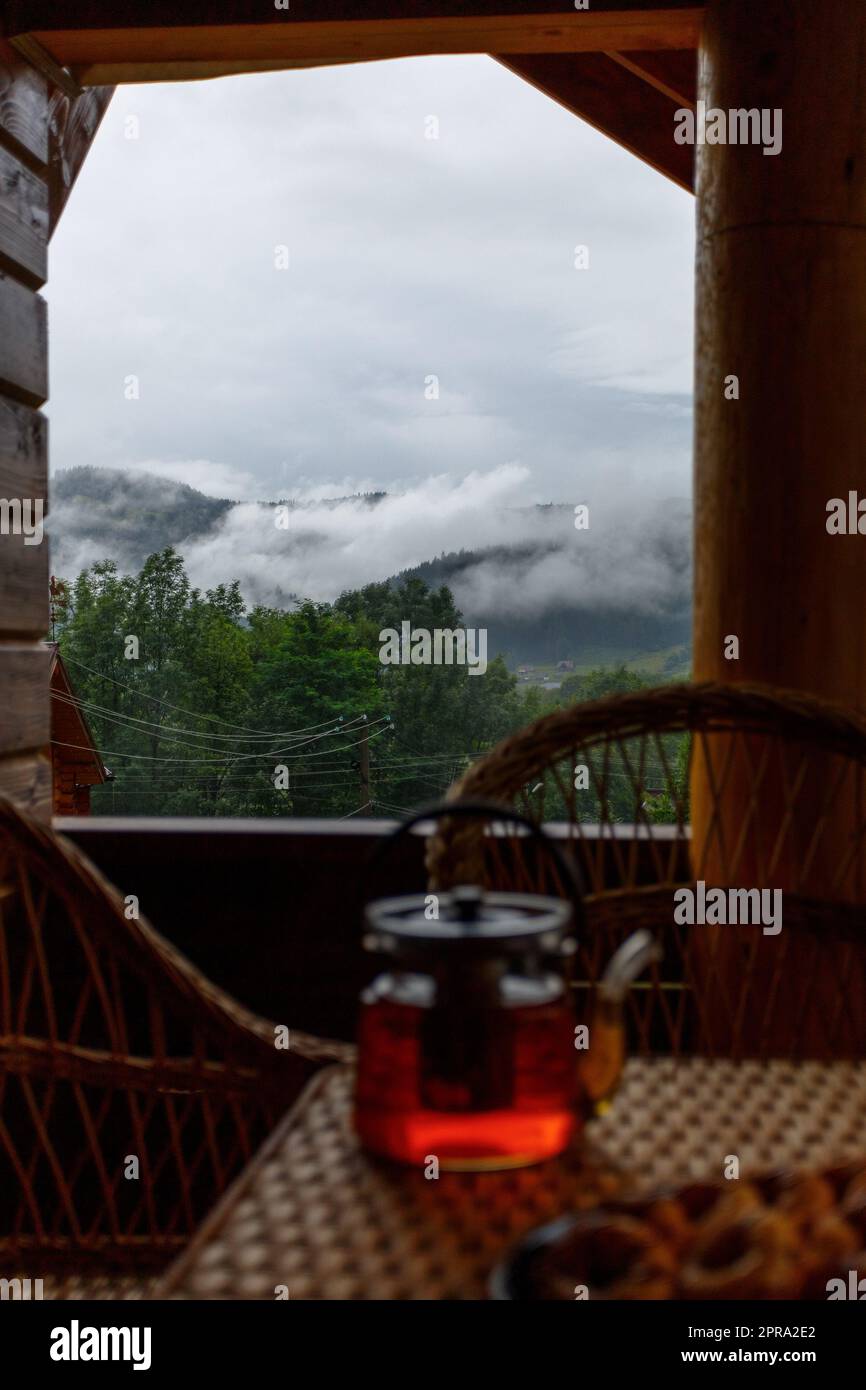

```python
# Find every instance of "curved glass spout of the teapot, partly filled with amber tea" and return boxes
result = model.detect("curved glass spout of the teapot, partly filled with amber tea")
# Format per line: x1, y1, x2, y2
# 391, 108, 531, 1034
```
578, 930, 662, 1112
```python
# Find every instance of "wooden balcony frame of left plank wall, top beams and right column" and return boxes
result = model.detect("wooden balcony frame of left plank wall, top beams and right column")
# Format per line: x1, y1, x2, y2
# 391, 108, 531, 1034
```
0, 0, 866, 928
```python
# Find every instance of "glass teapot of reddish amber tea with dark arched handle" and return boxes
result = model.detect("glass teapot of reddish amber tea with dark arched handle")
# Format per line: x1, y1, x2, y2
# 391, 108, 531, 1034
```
354, 802, 659, 1169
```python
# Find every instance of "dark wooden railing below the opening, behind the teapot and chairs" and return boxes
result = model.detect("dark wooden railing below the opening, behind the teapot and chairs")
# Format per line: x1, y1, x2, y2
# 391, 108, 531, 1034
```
54, 817, 686, 1038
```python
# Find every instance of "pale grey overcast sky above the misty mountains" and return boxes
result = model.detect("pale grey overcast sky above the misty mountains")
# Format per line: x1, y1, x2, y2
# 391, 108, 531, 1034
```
49, 57, 694, 517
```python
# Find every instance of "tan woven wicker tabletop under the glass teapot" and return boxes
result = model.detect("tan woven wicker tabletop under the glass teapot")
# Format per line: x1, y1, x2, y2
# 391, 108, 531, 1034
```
153, 1059, 866, 1300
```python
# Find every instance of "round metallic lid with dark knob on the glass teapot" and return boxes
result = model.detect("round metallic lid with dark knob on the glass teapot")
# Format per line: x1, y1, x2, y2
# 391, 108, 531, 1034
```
364, 884, 571, 955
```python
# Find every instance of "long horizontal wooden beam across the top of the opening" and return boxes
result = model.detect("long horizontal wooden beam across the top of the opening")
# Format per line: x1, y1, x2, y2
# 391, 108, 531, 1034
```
6, 0, 702, 86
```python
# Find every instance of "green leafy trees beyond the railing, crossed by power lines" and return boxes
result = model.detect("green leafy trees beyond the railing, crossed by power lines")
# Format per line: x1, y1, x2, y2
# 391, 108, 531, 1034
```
53, 546, 692, 820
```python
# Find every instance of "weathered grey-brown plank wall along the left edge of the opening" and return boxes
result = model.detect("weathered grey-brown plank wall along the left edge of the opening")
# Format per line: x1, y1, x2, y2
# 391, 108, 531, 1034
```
0, 44, 51, 819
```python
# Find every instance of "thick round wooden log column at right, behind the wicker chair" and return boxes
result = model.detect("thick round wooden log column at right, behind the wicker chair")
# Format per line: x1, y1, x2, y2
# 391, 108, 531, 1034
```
692, 0, 866, 1041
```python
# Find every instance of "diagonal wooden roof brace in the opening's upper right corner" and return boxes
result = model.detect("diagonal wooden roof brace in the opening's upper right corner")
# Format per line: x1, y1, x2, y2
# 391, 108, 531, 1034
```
498, 53, 694, 192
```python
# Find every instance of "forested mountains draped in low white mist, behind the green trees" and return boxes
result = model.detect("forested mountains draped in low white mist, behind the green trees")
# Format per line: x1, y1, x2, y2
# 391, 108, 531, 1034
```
49, 464, 691, 666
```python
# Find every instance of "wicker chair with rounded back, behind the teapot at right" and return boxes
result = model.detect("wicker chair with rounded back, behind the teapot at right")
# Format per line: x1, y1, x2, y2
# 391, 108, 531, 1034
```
427, 684, 866, 1058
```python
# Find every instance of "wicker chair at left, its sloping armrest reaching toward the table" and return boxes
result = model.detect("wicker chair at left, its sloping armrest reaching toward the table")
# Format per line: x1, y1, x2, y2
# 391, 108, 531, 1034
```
0, 798, 349, 1297
